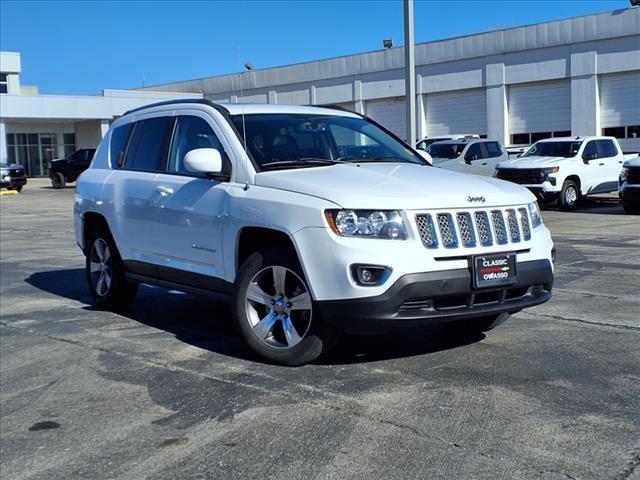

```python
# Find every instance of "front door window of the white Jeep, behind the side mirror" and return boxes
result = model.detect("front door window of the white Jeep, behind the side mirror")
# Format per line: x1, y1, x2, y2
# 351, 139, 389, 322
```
167, 116, 227, 175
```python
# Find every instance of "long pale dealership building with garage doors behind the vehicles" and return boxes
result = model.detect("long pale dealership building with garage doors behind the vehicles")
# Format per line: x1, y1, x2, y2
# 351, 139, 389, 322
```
0, 7, 640, 174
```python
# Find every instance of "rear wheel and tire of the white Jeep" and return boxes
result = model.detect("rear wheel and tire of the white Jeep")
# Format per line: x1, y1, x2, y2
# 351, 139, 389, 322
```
85, 227, 138, 311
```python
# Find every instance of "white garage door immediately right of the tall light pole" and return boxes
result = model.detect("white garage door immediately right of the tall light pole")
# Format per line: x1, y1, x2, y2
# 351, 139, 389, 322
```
427, 89, 487, 136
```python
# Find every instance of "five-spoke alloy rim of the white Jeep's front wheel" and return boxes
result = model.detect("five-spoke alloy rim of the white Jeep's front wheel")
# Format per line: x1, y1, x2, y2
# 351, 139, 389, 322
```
245, 265, 312, 348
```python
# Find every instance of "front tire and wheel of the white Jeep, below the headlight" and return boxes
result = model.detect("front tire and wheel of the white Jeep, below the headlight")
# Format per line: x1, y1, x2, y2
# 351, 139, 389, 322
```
232, 248, 338, 366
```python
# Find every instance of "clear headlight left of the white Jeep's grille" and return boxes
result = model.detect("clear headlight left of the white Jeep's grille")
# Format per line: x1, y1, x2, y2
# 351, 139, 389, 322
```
325, 210, 407, 240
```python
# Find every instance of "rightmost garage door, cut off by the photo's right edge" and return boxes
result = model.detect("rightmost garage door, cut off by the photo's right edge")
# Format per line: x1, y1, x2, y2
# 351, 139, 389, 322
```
600, 71, 640, 151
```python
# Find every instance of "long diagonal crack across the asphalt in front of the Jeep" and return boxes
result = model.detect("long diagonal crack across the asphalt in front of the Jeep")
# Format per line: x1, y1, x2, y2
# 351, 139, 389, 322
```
0, 321, 580, 479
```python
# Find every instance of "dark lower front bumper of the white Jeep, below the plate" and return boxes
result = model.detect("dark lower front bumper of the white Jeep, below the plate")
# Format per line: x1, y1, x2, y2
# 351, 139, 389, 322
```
317, 259, 553, 329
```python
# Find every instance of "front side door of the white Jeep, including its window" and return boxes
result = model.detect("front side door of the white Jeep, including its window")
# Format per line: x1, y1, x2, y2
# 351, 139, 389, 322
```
151, 110, 231, 290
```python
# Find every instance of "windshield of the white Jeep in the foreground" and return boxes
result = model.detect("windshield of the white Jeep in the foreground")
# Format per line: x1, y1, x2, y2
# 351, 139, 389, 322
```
231, 113, 426, 169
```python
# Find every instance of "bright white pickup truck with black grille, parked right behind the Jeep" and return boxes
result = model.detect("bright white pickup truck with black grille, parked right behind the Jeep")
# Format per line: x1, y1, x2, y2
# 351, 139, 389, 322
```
496, 137, 624, 211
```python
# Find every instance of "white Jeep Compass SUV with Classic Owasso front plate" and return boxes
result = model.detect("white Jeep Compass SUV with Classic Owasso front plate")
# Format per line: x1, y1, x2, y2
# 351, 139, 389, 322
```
74, 100, 553, 365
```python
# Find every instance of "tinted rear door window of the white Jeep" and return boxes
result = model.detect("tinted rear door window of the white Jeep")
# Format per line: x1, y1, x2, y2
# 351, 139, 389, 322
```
125, 117, 173, 172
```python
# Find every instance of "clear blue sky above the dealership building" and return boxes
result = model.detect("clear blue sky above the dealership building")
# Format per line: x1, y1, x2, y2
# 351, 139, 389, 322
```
0, 0, 629, 95
